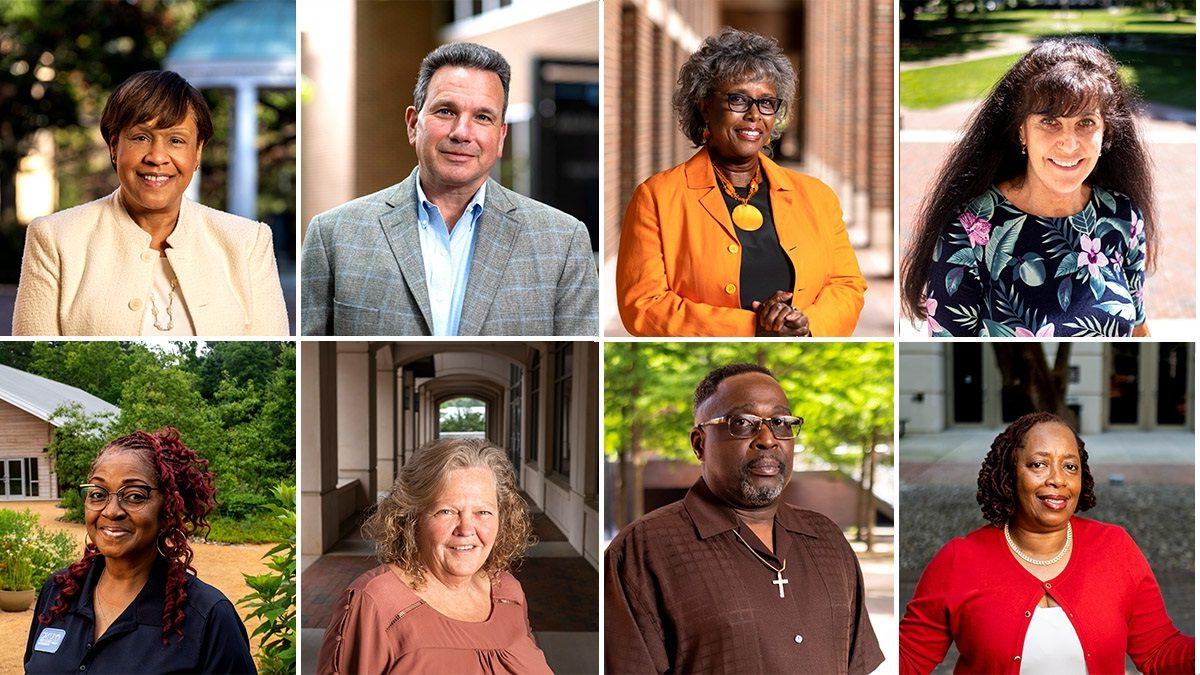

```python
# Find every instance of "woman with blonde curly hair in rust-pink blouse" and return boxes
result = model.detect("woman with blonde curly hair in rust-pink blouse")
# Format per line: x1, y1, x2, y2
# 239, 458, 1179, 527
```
318, 438, 551, 673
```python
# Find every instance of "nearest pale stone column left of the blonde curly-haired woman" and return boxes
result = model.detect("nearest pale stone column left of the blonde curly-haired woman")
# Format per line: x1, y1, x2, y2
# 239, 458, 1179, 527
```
337, 342, 377, 508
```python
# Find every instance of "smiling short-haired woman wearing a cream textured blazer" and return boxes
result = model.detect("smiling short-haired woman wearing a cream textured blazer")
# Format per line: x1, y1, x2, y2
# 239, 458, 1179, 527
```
12, 71, 288, 336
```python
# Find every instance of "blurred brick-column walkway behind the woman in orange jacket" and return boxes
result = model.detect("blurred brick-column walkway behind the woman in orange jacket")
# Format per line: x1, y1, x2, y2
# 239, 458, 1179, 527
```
600, 0, 895, 336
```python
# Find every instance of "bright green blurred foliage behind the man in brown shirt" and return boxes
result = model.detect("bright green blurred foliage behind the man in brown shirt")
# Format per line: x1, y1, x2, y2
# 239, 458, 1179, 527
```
604, 342, 893, 468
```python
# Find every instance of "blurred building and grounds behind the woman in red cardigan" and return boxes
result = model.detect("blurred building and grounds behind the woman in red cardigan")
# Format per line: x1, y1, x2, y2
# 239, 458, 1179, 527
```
896, 341, 1195, 673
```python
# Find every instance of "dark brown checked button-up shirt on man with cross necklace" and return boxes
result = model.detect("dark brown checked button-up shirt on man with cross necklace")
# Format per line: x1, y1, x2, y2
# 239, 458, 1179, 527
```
605, 478, 883, 674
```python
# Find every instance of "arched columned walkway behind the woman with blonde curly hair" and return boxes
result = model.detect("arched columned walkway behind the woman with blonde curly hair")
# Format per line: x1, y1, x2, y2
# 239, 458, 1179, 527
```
300, 341, 600, 673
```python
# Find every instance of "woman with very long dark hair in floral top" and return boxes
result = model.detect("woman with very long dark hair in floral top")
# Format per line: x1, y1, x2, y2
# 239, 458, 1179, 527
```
901, 38, 1157, 338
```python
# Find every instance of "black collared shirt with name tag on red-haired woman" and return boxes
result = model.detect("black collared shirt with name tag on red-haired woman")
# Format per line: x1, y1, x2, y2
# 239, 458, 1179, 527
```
25, 556, 256, 674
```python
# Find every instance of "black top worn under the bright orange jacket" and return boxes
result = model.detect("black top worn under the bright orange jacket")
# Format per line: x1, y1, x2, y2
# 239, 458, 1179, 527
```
714, 169, 796, 310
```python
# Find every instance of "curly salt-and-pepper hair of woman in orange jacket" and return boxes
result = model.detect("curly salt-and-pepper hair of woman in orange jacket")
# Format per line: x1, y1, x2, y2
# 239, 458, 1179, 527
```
671, 28, 796, 148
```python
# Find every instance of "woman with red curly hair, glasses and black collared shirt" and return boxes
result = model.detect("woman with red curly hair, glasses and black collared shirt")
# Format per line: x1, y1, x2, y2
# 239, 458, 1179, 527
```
25, 426, 256, 673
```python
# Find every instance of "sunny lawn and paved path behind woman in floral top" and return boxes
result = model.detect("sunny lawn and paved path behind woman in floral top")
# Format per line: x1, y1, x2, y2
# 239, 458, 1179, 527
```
899, 0, 1196, 338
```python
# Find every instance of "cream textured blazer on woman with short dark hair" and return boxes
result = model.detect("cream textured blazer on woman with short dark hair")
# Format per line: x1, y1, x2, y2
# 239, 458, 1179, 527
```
12, 189, 288, 336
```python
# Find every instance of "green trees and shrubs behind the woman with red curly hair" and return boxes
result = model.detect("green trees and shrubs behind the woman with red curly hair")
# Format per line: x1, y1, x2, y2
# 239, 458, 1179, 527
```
0, 341, 295, 528
